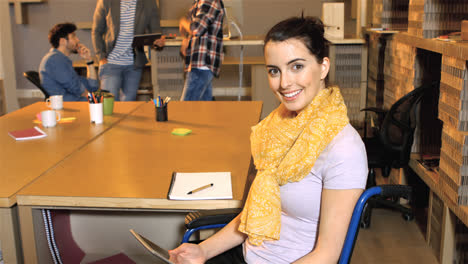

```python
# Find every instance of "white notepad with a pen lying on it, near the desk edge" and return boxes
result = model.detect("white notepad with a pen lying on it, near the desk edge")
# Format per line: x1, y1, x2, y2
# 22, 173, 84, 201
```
167, 172, 232, 200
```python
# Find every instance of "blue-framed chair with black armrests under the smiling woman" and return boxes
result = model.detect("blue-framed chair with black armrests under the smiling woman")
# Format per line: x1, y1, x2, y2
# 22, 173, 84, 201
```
182, 185, 412, 264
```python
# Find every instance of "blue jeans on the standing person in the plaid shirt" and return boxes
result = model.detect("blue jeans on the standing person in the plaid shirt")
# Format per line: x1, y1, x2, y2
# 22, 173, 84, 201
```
181, 69, 213, 101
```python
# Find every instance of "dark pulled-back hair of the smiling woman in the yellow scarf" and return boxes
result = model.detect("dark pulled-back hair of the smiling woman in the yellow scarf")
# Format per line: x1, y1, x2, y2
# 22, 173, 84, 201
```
265, 17, 329, 63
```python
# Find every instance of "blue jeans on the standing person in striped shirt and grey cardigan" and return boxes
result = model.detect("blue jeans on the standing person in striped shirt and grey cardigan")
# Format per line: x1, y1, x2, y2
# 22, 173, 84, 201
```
99, 63, 142, 101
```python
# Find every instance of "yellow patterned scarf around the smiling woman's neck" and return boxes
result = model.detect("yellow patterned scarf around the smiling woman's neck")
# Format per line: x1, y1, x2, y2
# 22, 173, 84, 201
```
239, 87, 349, 245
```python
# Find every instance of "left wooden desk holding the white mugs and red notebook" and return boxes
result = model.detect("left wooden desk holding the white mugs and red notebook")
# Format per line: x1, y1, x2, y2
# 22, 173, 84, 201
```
0, 102, 143, 263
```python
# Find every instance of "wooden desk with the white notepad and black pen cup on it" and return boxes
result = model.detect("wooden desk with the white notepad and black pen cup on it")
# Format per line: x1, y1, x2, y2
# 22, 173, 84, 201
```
18, 101, 262, 263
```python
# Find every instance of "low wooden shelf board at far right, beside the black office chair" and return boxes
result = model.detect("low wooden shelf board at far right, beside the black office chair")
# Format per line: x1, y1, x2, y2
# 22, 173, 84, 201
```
409, 156, 468, 226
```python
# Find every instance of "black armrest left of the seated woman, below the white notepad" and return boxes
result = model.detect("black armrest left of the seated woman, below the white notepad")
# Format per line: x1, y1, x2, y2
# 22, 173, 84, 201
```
185, 209, 242, 229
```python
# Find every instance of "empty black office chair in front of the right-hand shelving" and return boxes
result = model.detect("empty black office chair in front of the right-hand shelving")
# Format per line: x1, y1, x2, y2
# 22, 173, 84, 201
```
361, 83, 438, 228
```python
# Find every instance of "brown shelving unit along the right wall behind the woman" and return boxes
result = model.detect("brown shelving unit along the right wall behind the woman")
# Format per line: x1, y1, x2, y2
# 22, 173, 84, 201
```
367, 0, 468, 263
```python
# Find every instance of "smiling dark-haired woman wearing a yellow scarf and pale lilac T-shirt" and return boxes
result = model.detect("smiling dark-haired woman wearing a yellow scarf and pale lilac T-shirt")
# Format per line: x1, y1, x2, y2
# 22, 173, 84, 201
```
170, 17, 367, 264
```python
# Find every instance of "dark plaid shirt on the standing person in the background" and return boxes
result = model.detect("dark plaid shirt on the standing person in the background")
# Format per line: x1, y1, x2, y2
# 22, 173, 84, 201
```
185, 0, 224, 77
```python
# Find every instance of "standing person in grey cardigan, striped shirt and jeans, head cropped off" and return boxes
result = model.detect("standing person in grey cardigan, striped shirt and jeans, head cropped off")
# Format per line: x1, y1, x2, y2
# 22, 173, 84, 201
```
91, 0, 165, 101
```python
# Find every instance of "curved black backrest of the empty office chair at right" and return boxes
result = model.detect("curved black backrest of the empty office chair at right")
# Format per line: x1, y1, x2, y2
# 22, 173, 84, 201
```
379, 84, 432, 168
